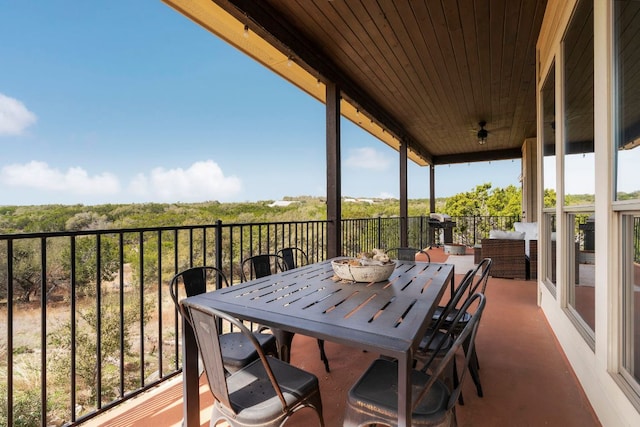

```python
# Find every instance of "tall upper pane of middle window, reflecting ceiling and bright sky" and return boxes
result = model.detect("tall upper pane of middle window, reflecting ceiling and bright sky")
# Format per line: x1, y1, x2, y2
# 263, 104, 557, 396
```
563, 0, 595, 206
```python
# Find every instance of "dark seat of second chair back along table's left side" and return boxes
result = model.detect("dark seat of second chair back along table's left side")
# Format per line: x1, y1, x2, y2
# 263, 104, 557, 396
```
219, 332, 277, 372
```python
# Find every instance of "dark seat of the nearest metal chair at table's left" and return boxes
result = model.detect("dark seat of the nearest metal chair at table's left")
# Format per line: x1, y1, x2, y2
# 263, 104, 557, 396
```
221, 357, 318, 425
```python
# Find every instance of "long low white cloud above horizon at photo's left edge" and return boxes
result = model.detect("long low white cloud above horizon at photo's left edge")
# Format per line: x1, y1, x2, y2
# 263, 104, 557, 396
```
0, 161, 120, 195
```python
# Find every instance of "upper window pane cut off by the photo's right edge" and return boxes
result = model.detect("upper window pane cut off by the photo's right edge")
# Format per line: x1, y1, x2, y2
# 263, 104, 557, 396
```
614, 1, 640, 200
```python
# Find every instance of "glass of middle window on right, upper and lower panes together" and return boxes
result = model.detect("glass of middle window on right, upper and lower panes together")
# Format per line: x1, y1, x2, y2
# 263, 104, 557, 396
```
558, 0, 595, 339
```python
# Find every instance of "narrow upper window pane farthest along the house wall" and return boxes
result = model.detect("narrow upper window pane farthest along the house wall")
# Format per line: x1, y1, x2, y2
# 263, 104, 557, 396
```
542, 63, 556, 208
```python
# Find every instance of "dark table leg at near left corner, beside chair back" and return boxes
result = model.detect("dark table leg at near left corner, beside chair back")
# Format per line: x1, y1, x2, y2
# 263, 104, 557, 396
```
182, 317, 200, 427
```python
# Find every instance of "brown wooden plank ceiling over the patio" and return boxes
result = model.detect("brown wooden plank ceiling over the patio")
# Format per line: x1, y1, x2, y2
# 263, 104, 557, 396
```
184, 0, 546, 165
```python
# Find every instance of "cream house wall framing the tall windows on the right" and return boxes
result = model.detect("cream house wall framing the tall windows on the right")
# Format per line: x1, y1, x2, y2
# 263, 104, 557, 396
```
537, 0, 640, 426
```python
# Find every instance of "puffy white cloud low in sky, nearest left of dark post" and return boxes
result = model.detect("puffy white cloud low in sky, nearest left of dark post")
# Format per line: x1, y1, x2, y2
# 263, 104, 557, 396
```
129, 160, 242, 202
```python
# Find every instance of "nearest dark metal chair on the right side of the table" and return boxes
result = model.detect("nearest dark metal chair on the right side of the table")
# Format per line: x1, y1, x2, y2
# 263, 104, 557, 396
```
343, 293, 485, 427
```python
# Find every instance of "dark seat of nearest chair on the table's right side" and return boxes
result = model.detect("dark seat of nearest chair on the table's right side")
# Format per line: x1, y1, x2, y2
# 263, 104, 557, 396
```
348, 359, 450, 425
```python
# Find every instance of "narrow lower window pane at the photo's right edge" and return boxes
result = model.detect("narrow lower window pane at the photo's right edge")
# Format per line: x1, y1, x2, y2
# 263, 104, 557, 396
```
621, 214, 640, 387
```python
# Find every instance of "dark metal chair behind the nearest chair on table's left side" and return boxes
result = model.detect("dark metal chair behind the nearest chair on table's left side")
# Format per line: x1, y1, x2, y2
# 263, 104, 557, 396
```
169, 266, 278, 372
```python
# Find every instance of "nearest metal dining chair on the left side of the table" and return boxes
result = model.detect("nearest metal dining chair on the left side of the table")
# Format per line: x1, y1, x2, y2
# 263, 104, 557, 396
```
181, 300, 324, 427
